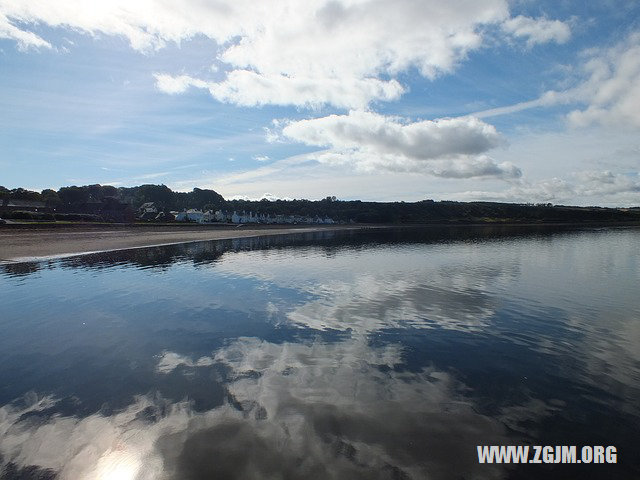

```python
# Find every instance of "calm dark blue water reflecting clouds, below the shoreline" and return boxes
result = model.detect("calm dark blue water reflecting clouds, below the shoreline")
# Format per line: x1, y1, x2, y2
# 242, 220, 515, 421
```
0, 229, 640, 480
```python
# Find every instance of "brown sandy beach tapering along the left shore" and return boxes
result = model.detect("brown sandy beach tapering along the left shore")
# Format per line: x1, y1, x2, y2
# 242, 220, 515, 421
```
0, 225, 358, 263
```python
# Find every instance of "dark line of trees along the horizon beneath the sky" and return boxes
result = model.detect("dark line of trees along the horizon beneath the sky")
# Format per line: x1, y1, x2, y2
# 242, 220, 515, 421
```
0, 184, 640, 224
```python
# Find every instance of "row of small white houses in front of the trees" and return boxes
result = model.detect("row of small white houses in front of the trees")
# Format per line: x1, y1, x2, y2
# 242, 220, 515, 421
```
172, 209, 336, 225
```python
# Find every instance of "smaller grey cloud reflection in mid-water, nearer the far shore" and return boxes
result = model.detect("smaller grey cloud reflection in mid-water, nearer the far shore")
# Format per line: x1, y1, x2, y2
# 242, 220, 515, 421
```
210, 243, 519, 333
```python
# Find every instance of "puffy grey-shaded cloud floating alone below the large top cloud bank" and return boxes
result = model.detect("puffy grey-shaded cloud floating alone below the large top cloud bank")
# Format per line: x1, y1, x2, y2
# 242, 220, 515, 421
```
281, 111, 521, 178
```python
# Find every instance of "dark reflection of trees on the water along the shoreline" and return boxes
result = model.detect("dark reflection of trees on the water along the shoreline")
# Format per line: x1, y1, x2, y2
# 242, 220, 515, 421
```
0, 225, 592, 276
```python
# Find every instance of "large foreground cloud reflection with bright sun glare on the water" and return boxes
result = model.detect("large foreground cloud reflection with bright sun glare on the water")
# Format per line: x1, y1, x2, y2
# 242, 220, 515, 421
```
0, 336, 507, 480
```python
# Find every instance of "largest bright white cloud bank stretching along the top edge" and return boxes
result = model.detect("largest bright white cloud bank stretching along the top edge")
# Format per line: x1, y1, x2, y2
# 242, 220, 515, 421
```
0, 0, 568, 108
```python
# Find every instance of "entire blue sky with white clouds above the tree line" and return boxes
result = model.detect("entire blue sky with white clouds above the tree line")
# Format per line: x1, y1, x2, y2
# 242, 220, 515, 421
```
0, 0, 640, 206
